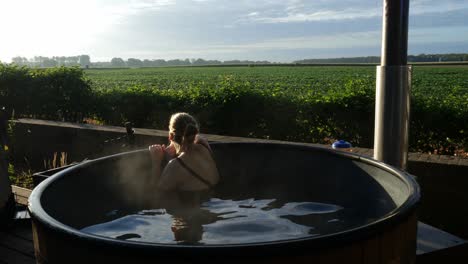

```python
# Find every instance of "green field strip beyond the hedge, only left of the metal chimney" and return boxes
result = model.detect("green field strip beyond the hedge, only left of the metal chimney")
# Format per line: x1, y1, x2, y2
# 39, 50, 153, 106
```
86, 66, 376, 92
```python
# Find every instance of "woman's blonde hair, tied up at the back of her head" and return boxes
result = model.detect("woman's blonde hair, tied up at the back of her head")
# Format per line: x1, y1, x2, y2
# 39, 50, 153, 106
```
169, 113, 200, 152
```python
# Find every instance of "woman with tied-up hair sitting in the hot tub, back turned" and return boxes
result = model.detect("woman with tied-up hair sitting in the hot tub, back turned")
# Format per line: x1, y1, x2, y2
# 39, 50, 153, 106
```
149, 113, 219, 208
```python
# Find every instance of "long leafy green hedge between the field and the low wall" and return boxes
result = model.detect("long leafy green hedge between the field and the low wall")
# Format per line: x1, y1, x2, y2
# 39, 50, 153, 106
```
0, 65, 468, 154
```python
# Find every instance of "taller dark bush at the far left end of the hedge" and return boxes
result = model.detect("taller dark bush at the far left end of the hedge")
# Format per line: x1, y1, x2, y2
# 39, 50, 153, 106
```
0, 64, 94, 121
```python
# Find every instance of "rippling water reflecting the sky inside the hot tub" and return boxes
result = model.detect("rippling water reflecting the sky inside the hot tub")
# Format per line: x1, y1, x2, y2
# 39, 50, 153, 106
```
82, 198, 352, 245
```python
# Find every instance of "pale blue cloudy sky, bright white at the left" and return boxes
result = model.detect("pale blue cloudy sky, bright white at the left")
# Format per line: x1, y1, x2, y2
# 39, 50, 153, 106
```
0, 0, 468, 62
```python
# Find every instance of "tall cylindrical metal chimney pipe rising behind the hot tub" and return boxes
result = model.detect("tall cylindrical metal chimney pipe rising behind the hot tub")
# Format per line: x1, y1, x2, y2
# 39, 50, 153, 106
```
374, 0, 411, 169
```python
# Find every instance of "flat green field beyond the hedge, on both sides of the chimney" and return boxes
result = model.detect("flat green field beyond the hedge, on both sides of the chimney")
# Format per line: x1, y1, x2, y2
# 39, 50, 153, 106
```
85, 65, 468, 96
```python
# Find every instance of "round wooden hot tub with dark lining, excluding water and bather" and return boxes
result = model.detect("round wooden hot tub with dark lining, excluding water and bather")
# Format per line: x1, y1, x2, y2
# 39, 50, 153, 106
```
29, 143, 420, 263
